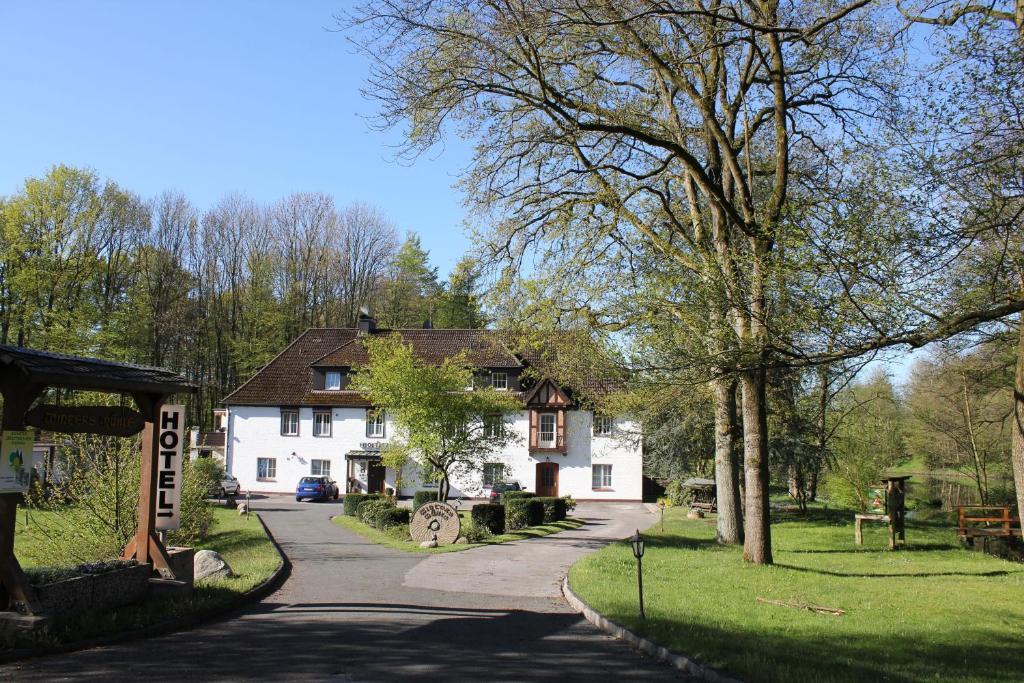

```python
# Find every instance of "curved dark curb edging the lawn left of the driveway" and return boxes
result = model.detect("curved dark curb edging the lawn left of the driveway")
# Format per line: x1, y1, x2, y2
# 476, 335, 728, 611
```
0, 513, 292, 664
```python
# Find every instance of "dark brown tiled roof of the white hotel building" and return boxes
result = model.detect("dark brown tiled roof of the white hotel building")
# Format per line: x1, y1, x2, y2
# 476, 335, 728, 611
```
224, 328, 606, 407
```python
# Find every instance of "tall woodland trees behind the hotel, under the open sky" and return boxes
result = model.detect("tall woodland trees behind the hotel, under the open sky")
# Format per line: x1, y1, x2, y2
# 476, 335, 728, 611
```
0, 166, 484, 428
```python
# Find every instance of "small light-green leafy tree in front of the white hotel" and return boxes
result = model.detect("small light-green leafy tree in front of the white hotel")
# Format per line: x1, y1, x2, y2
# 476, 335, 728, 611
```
352, 335, 521, 501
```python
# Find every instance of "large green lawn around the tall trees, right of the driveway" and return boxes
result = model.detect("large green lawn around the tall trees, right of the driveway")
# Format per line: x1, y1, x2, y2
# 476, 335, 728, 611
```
569, 508, 1024, 683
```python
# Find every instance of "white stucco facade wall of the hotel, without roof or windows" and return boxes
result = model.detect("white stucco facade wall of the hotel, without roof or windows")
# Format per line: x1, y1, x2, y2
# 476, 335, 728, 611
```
227, 407, 643, 501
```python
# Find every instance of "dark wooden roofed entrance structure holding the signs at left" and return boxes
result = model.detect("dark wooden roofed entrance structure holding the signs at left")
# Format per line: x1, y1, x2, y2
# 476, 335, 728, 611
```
0, 344, 196, 614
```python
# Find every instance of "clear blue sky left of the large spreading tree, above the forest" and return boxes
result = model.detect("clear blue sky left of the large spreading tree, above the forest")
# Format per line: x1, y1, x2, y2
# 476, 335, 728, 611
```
0, 0, 469, 273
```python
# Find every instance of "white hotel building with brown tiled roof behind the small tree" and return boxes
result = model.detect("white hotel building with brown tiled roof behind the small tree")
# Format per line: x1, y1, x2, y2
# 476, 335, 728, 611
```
224, 316, 642, 501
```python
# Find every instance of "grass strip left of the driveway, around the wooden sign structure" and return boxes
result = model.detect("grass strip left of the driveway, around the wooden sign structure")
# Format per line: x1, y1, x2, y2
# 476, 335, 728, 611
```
7, 508, 281, 647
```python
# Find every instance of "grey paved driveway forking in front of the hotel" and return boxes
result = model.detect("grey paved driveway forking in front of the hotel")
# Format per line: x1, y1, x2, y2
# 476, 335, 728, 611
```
0, 499, 680, 683
